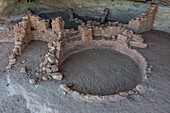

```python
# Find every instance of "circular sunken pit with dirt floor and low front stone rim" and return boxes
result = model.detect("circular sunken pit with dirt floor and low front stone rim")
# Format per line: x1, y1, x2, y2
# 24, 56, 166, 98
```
60, 47, 147, 102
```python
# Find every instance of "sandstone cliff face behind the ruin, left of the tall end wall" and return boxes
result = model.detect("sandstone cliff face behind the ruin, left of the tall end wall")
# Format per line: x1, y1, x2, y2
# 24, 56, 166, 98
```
0, 0, 150, 23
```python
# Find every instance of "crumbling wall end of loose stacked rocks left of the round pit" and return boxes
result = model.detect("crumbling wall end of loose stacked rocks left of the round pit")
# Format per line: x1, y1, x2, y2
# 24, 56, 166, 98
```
40, 41, 63, 80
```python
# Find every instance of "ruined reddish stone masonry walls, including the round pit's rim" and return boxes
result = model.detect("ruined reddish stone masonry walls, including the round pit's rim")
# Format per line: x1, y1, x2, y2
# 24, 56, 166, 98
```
0, 5, 157, 102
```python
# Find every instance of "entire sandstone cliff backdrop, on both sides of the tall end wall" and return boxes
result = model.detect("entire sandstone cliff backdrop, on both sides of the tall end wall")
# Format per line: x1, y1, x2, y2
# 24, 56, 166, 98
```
0, 0, 170, 32
